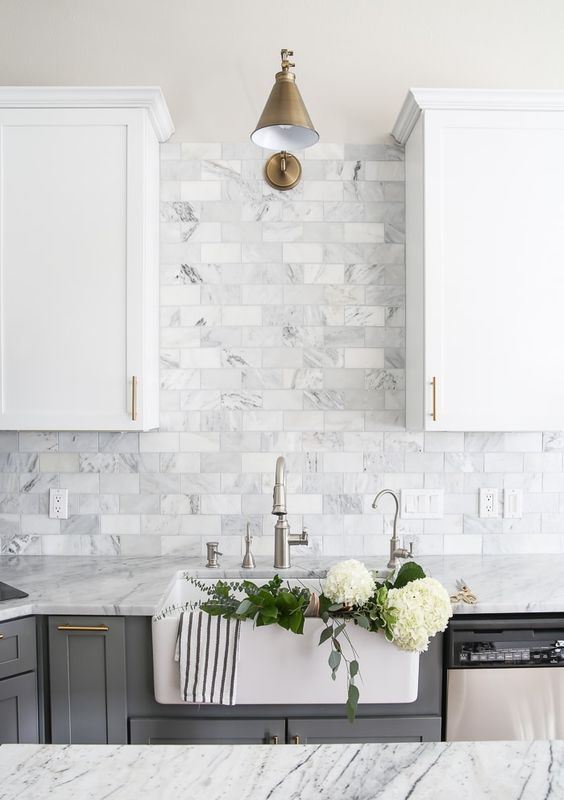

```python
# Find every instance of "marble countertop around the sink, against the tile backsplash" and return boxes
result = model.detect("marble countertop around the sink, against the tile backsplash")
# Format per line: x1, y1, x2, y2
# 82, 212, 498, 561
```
0, 555, 564, 620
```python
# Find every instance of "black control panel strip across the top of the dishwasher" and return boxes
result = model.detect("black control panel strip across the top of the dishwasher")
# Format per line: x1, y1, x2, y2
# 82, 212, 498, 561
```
455, 640, 564, 668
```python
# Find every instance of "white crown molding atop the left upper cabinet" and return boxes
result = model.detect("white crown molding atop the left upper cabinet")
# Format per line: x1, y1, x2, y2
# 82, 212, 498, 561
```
0, 86, 174, 142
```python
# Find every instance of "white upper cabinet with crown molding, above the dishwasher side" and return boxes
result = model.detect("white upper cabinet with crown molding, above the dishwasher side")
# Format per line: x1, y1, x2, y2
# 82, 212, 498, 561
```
394, 90, 564, 431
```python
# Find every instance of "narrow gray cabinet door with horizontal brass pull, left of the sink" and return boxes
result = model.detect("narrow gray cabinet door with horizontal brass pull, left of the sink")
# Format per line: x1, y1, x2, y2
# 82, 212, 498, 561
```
49, 617, 127, 744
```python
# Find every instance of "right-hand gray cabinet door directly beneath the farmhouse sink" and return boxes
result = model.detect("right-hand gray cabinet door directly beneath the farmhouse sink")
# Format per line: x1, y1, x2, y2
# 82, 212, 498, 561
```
288, 717, 441, 744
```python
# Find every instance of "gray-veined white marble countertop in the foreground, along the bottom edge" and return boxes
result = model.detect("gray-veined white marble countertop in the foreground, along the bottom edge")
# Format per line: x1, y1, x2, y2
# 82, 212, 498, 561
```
0, 742, 564, 800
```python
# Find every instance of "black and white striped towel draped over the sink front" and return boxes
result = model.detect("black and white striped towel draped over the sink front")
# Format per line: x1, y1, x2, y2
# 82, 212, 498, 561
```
174, 611, 241, 706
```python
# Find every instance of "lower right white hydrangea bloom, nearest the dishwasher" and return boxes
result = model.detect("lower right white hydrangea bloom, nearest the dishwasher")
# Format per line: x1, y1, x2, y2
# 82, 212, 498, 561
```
388, 578, 452, 653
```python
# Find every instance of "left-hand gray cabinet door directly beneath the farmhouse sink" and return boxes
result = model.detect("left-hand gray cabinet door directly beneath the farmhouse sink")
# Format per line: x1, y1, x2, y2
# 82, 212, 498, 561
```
129, 717, 286, 744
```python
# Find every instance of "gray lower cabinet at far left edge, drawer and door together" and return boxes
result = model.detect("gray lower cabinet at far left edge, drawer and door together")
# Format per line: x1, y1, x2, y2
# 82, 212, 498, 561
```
0, 617, 39, 744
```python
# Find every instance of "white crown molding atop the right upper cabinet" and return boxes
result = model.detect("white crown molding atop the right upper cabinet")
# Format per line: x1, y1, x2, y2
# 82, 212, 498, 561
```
392, 89, 564, 144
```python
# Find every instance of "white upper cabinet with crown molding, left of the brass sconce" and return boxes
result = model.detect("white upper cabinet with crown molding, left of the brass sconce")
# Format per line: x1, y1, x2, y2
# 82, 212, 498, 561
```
0, 88, 173, 431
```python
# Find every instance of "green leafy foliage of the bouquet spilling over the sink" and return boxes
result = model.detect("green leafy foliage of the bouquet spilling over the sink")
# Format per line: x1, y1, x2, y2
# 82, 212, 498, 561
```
187, 561, 425, 723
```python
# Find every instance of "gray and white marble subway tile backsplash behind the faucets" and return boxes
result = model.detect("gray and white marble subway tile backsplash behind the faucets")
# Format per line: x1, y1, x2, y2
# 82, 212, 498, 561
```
0, 143, 564, 557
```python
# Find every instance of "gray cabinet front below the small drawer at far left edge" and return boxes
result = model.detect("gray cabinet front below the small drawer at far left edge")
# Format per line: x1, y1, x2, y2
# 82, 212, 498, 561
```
0, 672, 39, 744
